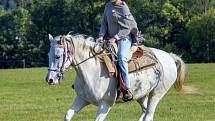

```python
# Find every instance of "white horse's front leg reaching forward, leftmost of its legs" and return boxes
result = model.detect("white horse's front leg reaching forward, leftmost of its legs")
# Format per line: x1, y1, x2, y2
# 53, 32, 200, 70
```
64, 96, 89, 121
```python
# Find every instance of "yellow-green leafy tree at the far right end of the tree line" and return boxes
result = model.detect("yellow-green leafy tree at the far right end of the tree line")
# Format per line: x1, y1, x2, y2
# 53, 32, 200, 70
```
187, 8, 215, 62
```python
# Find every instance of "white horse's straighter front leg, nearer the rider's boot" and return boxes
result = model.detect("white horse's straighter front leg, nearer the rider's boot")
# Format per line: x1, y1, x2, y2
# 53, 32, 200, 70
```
95, 102, 111, 121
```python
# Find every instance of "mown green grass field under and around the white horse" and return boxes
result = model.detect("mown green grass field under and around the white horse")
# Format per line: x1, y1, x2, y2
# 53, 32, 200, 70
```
0, 64, 215, 121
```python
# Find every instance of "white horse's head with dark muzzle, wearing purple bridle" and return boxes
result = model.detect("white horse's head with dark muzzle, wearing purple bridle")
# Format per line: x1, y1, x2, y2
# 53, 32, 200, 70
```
46, 34, 72, 85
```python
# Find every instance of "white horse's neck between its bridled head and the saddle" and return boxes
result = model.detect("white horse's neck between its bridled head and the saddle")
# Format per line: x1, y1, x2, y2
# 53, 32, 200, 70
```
73, 37, 101, 86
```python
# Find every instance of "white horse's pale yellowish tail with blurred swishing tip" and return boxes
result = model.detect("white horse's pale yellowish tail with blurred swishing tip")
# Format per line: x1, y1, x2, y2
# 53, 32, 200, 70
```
170, 53, 197, 93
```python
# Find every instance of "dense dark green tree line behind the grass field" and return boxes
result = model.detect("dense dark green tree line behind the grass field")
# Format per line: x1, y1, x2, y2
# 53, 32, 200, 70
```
0, 0, 215, 68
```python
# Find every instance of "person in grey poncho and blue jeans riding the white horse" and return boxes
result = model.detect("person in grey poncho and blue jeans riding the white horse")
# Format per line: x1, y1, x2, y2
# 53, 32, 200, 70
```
97, 0, 139, 101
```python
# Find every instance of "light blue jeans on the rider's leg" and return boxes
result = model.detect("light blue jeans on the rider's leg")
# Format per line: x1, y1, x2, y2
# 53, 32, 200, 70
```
117, 35, 132, 89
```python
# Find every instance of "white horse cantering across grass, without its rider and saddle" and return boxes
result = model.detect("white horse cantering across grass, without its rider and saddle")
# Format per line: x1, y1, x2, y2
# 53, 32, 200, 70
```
46, 35, 185, 121
